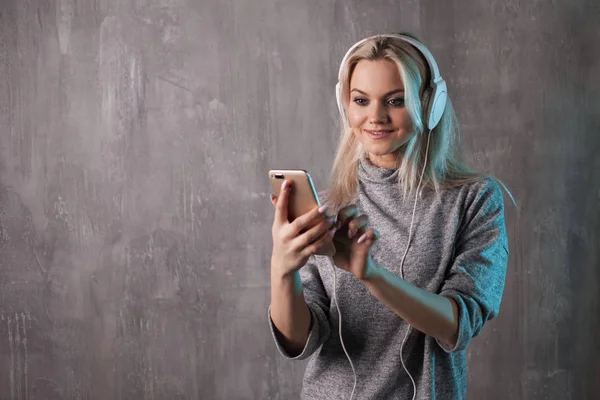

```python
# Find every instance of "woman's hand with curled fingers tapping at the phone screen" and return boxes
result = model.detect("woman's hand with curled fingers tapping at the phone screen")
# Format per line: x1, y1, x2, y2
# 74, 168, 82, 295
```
333, 204, 379, 280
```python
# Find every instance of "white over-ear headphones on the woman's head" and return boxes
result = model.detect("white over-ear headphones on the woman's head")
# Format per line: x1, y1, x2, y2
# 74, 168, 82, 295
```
335, 34, 448, 131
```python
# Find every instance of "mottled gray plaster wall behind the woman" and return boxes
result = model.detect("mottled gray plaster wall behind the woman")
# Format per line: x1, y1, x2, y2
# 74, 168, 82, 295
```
0, 0, 600, 400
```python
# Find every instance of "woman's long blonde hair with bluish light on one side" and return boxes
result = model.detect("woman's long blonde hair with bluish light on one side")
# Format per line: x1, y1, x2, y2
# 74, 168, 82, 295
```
325, 33, 516, 210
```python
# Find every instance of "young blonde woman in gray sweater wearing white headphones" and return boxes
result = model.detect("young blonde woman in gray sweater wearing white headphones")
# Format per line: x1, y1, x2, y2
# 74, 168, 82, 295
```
269, 34, 512, 400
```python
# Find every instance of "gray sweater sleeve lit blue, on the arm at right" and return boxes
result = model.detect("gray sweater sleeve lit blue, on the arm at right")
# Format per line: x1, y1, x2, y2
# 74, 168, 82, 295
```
437, 180, 509, 353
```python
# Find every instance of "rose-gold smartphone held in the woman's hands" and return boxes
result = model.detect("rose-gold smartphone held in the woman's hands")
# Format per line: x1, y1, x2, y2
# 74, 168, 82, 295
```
269, 169, 335, 256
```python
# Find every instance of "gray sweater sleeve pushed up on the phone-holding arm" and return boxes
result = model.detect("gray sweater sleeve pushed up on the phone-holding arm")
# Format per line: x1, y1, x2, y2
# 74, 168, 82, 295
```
268, 257, 330, 360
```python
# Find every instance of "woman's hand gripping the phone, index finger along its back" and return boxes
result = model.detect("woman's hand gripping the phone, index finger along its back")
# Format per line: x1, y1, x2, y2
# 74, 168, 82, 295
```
271, 181, 336, 277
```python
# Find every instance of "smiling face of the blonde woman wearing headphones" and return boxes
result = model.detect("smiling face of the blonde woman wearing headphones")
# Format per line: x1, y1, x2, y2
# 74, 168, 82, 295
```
348, 60, 413, 169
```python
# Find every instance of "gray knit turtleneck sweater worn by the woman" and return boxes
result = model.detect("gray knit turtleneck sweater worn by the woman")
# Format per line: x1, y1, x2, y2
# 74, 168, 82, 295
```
269, 161, 508, 400
